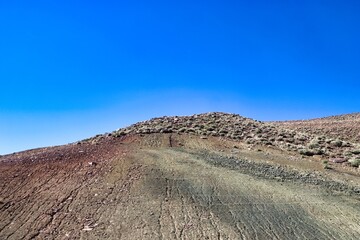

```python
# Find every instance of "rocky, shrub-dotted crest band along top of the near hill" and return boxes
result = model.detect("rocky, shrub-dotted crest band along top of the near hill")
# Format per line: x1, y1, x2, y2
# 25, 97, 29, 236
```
88, 112, 360, 167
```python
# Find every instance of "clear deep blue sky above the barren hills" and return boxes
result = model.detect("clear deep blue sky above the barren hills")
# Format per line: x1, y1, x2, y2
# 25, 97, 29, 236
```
0, 0, 360, 154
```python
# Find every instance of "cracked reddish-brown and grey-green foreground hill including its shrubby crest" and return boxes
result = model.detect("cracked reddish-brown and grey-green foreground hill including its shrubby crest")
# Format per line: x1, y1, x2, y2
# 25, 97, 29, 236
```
0, 113, 360, 239
